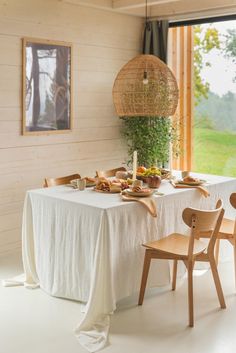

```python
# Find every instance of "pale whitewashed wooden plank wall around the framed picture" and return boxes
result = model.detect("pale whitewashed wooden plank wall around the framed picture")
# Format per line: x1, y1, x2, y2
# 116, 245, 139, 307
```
0, 0, 142, 254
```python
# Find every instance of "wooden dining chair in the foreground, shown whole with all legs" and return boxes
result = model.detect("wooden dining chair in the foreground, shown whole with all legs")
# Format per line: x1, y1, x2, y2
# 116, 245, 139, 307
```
138, 200, 226, 327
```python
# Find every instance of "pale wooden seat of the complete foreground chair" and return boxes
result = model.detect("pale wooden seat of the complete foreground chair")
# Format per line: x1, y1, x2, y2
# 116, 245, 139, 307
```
143, 233, 207, 257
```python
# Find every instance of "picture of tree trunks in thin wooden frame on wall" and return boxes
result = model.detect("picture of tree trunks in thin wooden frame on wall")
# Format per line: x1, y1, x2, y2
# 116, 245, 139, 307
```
22, 38, 72, 135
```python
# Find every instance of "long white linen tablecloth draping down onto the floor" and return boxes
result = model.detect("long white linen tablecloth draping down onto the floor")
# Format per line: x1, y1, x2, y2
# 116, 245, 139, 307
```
22, 175, 236, 352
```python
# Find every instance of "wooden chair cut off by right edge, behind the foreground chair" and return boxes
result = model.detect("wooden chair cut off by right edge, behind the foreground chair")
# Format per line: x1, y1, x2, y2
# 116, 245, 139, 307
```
200, 193, 236, 286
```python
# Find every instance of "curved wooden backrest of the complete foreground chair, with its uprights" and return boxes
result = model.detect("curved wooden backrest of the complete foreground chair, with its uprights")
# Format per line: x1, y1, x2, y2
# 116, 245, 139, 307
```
182, 200, 224, 257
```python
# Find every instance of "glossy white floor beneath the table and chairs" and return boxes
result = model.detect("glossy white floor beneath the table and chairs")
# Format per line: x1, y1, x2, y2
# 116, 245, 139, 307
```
0, 253, 236, 353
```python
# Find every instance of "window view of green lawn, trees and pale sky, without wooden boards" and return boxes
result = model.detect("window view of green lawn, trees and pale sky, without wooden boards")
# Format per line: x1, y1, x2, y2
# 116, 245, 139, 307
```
193, 20, 236, 176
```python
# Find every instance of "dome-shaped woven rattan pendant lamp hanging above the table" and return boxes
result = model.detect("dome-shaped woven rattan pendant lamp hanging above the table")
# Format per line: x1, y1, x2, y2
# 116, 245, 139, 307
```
112, 1, 179, 117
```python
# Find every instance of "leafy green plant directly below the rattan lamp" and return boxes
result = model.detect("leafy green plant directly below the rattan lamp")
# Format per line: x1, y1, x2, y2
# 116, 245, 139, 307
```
121, 116, 177, 167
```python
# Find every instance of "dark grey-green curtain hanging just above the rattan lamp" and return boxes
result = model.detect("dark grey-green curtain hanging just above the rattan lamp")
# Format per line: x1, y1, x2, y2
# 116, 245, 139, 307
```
143, 21, 169, 63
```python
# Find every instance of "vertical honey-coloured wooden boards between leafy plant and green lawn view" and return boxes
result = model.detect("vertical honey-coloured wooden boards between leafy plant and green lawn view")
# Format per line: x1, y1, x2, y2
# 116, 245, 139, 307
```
168, 26, 194, 170
